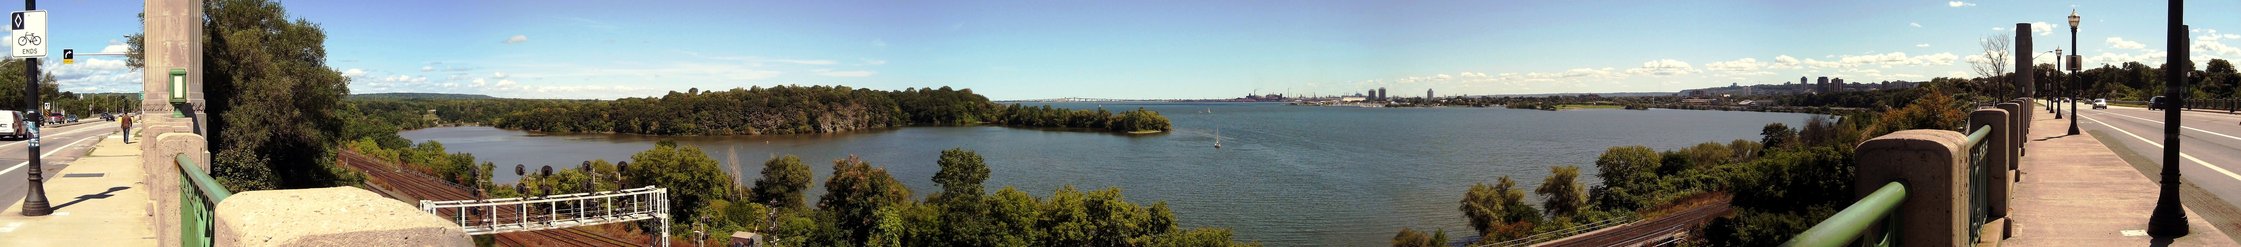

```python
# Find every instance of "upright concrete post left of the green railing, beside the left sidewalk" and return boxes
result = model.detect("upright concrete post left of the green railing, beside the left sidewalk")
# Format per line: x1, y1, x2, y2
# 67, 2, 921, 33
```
141, 132, 211, 245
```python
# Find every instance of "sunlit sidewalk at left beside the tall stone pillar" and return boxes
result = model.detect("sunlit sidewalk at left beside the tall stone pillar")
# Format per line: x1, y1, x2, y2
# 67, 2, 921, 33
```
0, 135, 157, 247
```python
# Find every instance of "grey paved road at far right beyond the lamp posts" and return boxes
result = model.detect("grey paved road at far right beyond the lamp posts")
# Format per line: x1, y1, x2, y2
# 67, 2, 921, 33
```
2070, 106, 2241, 204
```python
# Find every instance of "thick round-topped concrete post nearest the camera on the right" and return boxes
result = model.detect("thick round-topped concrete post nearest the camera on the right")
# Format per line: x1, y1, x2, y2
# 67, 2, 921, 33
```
1853, 130, 1968, 247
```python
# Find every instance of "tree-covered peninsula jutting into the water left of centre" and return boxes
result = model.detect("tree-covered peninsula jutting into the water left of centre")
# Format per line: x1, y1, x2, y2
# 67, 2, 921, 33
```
350, 85, 1172, 135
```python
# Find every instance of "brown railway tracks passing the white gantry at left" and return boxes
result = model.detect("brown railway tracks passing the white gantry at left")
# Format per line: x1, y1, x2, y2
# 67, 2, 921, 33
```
336, 150, 648, 247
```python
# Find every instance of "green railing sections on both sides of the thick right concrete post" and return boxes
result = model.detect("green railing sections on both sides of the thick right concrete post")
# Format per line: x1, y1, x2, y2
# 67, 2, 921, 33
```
1782, 126, 1992, 247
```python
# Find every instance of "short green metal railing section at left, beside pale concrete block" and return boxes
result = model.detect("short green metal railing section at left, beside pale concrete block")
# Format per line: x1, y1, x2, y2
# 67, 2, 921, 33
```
177, 153, 233, 247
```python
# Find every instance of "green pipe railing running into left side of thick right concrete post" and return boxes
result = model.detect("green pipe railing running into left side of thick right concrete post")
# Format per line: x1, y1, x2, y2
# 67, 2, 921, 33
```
1782, 182, 1907, 247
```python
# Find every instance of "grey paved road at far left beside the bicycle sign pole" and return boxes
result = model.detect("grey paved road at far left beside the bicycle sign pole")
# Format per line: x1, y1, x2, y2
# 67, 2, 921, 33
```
0, 121, 123, 209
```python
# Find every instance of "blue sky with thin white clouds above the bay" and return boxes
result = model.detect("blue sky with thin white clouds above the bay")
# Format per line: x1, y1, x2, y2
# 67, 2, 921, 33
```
18, 0, 2241, 99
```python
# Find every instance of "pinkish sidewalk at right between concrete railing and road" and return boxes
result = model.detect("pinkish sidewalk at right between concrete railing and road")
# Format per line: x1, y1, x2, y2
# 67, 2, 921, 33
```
2001, 108, 2237, 247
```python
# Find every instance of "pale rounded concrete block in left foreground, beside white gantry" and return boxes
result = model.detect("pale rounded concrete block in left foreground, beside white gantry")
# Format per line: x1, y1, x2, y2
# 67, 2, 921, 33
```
213, 186, 475, 247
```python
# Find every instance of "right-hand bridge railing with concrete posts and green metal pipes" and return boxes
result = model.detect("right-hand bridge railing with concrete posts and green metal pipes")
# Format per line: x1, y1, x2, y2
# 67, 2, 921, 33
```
1788, 101, 2033, 247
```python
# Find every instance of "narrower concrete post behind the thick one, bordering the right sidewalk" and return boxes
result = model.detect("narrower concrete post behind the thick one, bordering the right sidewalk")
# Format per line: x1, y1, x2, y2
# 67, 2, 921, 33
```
1963, 103, 2017, 236
